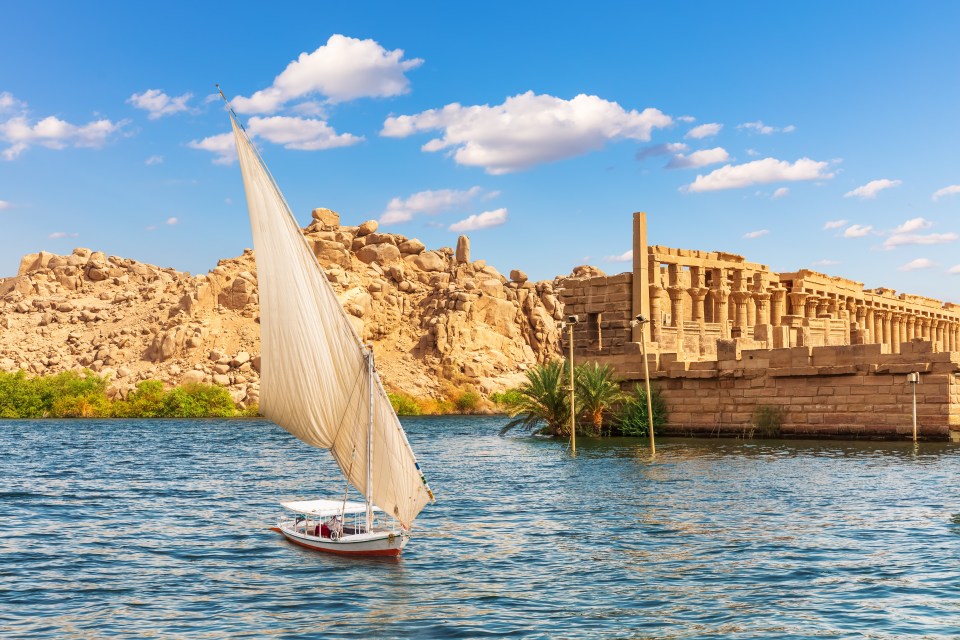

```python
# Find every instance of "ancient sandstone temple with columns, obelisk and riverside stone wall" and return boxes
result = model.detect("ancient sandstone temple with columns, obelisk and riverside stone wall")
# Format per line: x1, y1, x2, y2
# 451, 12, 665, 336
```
560, 213, 960, 438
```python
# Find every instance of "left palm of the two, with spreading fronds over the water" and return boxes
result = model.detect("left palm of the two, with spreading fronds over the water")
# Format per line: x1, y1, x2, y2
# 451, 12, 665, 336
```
500, 361, 570, 436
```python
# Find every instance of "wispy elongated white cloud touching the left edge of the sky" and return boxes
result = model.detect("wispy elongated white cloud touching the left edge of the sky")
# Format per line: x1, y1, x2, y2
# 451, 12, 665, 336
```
0, 110, 126, 160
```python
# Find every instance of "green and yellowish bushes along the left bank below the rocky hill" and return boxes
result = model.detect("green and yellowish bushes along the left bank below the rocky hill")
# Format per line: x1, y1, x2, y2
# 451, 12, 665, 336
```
0, 371, 257, 418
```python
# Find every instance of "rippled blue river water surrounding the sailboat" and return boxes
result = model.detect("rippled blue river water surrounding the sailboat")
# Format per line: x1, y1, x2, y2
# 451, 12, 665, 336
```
0, 417, 960, 638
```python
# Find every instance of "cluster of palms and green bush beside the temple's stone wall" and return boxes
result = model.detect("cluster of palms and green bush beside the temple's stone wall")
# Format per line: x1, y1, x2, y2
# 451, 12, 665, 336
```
501, 362, 667, 436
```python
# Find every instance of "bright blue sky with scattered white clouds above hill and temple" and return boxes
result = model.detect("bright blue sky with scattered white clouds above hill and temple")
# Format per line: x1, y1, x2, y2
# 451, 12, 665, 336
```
0, 2, 960, 302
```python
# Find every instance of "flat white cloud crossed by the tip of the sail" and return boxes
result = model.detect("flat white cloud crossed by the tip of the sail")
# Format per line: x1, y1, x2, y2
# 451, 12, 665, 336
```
187, 116, 363, 164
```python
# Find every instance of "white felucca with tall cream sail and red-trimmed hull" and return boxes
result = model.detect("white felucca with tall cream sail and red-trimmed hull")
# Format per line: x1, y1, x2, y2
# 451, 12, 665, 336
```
220, 93, 433, 555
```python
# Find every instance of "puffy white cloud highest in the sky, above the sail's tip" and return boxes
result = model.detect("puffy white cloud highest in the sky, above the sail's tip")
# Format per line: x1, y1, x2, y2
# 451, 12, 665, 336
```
232, 34, 423, 113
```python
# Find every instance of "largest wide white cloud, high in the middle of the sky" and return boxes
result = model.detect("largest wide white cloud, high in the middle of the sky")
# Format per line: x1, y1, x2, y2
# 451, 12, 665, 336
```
380, 91, 673, 175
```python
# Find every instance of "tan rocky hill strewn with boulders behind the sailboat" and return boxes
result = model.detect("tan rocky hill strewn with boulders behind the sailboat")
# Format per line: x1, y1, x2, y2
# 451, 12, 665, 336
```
0, 209, 563, 404
